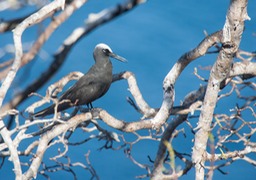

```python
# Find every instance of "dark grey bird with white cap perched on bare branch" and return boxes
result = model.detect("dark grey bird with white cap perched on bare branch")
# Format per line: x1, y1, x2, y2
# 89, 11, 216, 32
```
33, 43, 127, 117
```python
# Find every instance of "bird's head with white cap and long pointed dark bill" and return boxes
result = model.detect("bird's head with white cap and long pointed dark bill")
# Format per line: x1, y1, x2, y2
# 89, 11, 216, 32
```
93, 43, 127, 62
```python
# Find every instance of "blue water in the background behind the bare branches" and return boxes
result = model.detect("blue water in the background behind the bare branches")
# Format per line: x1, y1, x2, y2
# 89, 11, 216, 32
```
0, 0, 256, 180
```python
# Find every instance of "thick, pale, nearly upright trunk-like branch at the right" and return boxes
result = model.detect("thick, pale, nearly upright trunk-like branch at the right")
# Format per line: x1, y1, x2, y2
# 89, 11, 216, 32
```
192, 0, 248, 180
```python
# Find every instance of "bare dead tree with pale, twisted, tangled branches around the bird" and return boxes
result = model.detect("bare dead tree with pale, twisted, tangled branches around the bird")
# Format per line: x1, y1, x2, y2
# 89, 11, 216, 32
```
0, 0, 256, 180
